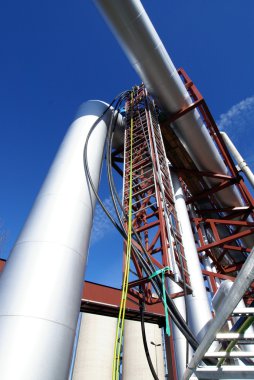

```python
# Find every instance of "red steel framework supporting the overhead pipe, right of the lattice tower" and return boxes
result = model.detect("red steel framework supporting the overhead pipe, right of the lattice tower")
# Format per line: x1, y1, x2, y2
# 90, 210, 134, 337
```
170, 69, 254, 302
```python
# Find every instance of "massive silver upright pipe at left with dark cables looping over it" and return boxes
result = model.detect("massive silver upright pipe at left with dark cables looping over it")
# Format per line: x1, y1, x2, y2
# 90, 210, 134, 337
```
0, 101, 111, 380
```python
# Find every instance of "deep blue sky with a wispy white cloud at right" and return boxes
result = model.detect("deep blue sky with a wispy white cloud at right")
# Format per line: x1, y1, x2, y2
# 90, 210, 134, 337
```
0, 0, 254, 285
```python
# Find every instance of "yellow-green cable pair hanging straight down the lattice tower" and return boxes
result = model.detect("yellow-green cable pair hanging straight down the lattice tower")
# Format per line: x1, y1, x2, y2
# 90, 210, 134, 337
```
112, 93, 133, 380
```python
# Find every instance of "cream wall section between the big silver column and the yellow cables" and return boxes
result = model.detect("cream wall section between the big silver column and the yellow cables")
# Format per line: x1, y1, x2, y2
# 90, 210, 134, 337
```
72, 313, 117, 380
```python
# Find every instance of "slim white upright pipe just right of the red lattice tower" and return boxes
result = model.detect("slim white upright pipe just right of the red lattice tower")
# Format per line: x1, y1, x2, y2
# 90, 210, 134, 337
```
172, 173, 212, 341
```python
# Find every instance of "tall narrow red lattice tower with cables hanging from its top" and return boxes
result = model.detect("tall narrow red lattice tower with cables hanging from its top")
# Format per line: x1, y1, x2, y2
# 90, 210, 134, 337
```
123, 86, 190, 303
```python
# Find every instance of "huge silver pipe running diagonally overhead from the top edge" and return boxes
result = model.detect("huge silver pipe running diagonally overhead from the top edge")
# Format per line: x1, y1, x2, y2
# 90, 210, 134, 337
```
94, 0, 242, 206
